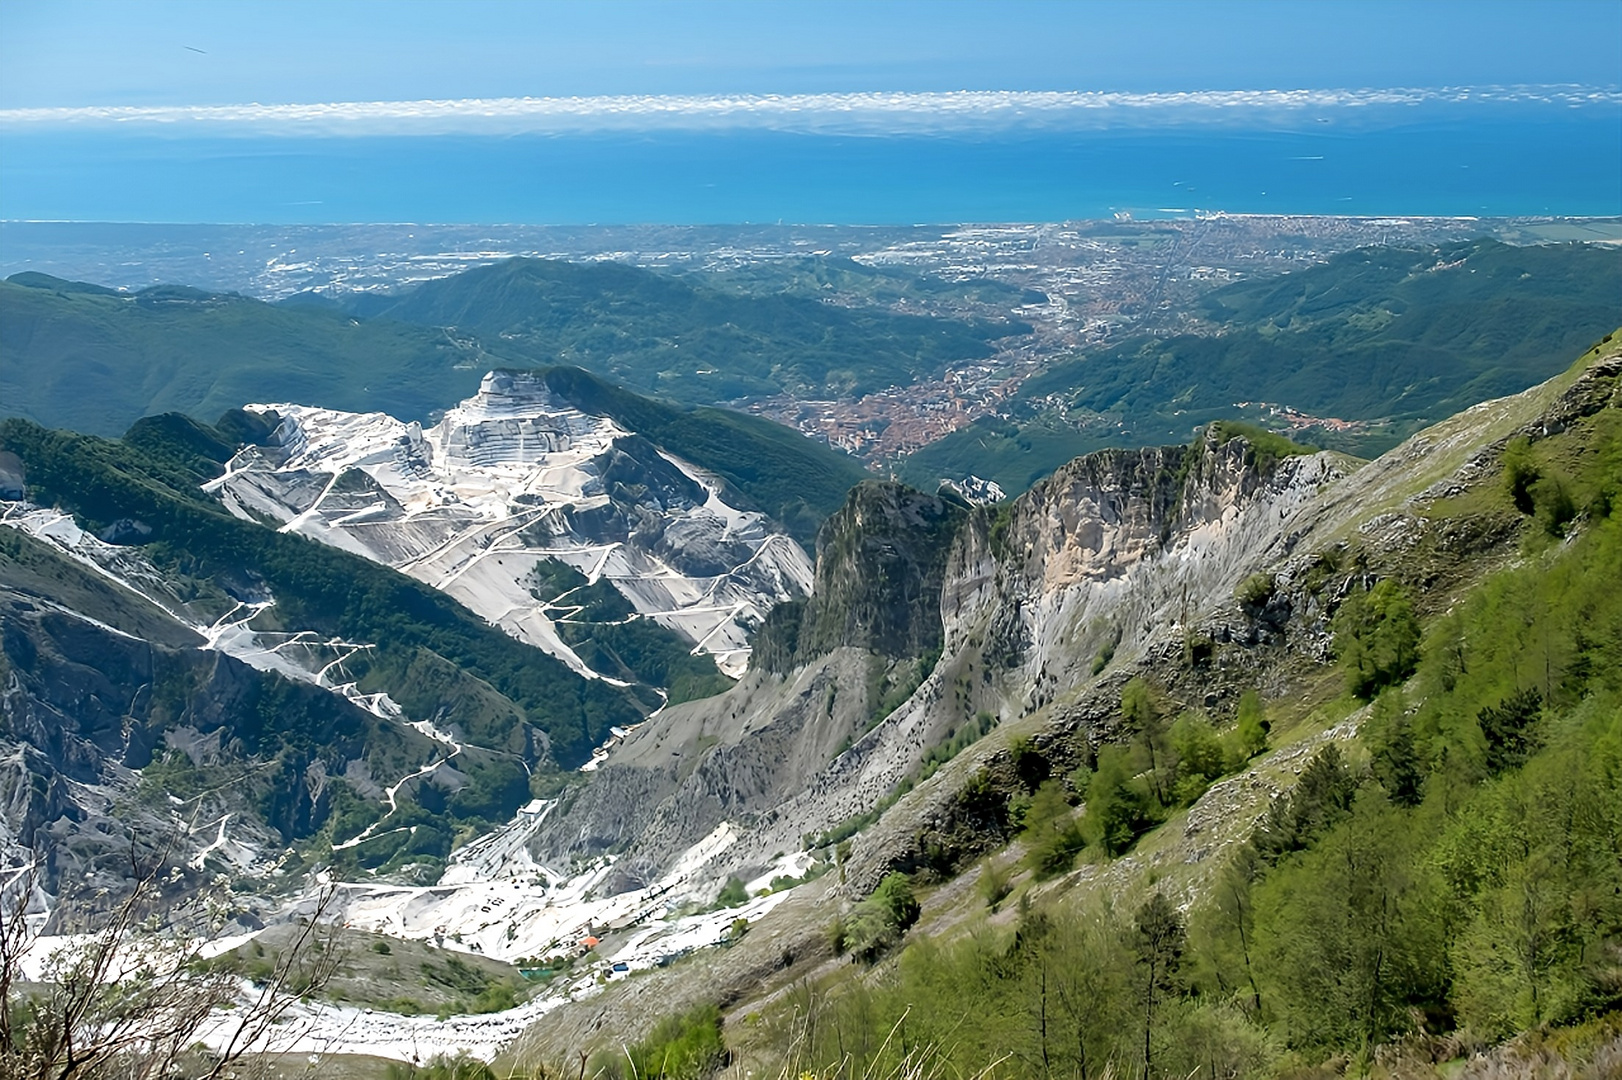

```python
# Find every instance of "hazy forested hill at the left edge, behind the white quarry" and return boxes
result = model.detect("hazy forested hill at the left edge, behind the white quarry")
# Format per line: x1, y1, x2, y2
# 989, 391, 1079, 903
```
0, 274, 498, 436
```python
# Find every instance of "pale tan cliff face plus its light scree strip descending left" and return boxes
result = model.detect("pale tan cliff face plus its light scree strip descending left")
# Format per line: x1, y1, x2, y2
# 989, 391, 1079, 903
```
735, 438, 1345, 889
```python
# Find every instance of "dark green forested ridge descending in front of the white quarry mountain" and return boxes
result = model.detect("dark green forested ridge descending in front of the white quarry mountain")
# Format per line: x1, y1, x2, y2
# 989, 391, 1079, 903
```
0, 418, 650, 765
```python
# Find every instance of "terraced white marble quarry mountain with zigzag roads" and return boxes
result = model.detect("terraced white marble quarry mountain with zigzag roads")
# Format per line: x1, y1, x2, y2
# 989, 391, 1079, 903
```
208, 371, 811, 678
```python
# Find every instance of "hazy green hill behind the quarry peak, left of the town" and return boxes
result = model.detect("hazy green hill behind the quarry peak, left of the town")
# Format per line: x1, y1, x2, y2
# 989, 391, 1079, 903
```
350, 259, 1030, 404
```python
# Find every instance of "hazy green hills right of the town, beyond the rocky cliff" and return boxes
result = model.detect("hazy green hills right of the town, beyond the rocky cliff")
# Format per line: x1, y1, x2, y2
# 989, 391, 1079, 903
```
905, 240, 1622, 491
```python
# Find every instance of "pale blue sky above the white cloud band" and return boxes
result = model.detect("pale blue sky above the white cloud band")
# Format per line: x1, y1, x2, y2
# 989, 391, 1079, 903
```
0, 0, 1622, 109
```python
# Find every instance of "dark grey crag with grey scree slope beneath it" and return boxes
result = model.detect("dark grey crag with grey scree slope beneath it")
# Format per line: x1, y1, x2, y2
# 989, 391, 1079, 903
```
532, 482, 968, 885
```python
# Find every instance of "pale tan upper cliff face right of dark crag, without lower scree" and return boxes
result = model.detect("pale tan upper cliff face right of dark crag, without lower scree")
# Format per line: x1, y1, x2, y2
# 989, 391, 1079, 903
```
941, 436, 1346, 710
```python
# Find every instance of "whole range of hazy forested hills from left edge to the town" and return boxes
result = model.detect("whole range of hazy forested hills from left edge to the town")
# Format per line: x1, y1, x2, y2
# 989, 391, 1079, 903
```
0, 259, 1030, 435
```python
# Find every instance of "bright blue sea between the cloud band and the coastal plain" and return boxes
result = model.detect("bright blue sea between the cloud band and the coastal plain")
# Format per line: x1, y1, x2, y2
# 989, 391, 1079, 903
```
0, 109, 1622, 224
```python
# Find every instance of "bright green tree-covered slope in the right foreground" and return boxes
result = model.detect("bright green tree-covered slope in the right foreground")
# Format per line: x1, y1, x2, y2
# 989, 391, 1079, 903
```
736, 397, 1622, 1078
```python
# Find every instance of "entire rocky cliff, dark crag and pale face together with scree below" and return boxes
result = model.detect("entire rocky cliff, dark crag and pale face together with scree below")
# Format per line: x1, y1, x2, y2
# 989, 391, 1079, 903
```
528, 436, 1345, 889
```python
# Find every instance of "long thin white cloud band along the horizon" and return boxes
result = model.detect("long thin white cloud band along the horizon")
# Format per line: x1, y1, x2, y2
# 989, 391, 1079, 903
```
0, 86, 1622, 135
